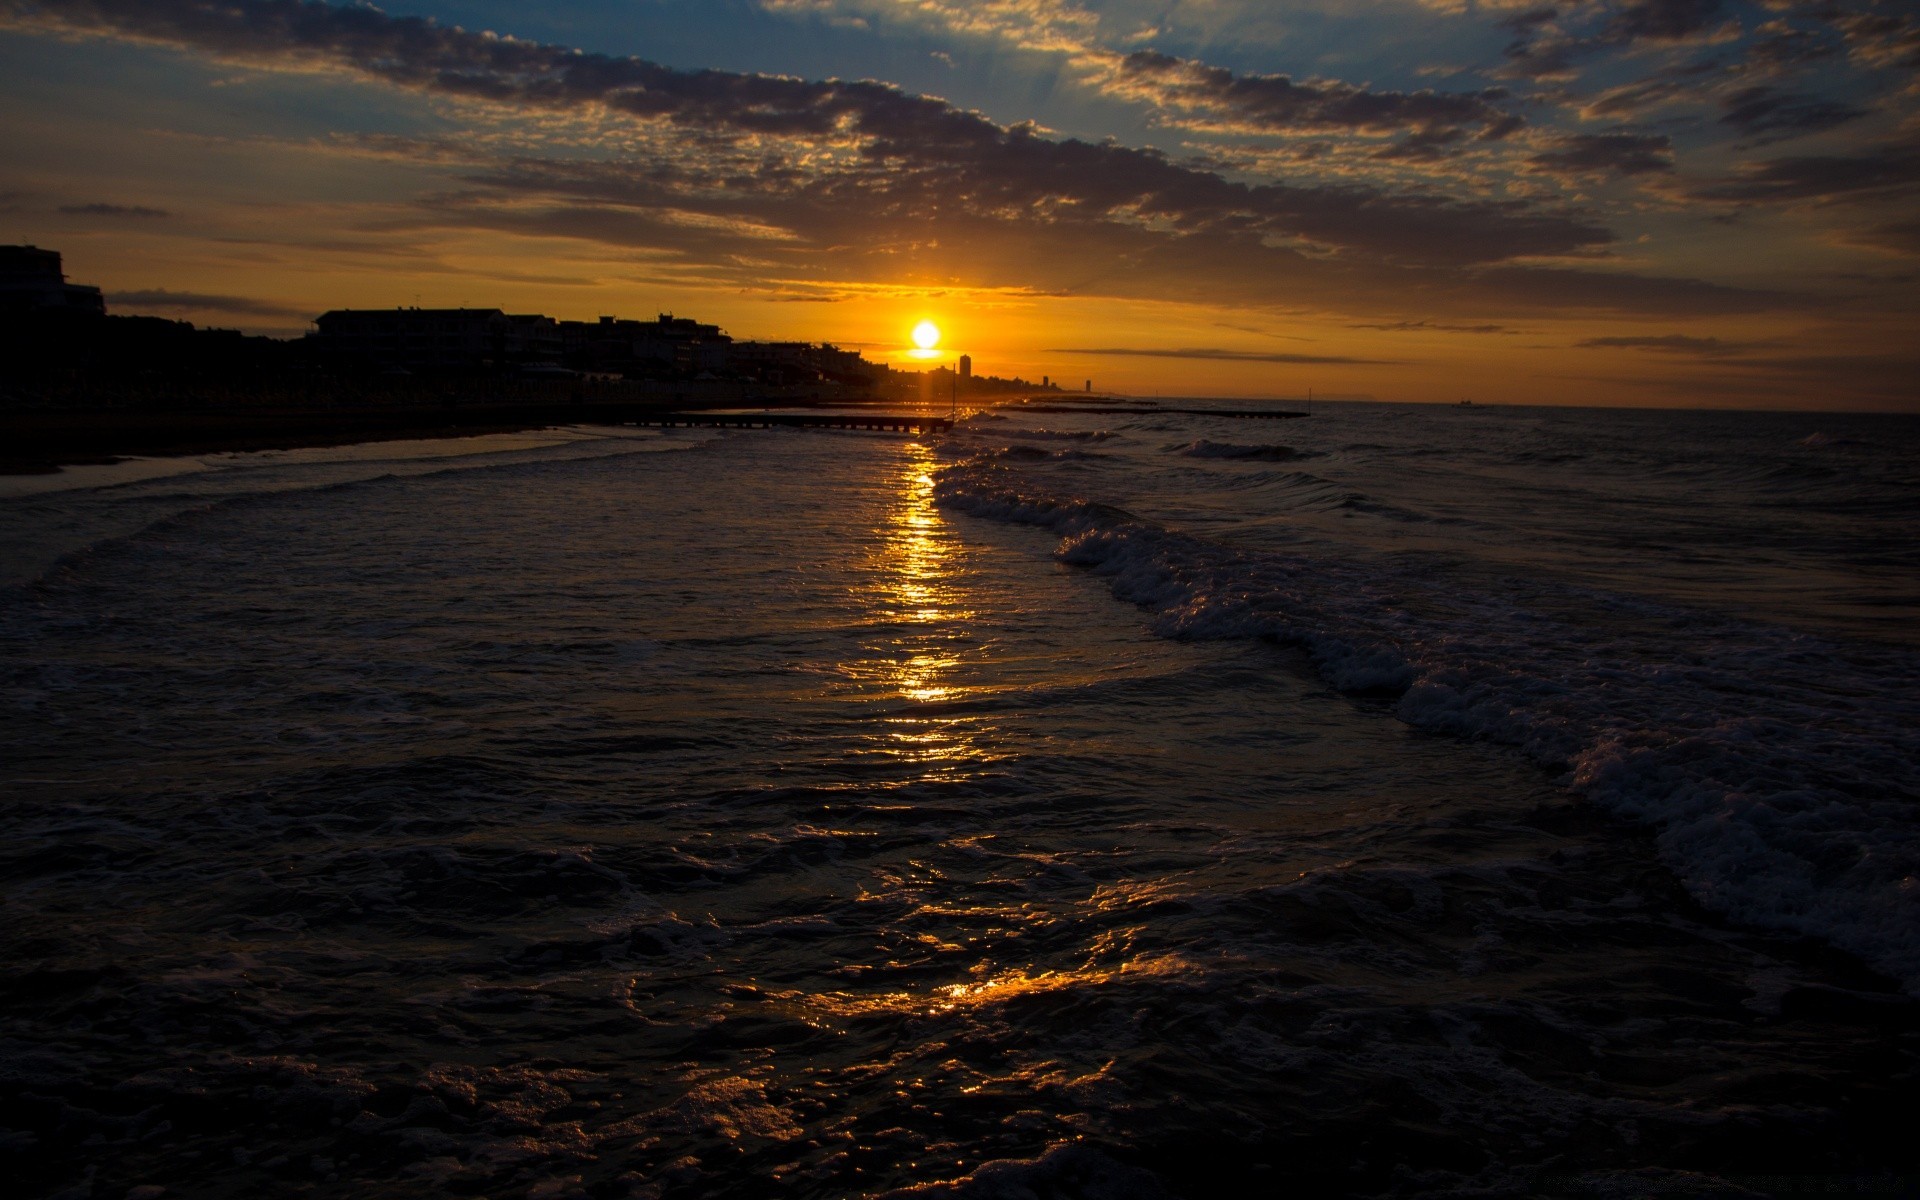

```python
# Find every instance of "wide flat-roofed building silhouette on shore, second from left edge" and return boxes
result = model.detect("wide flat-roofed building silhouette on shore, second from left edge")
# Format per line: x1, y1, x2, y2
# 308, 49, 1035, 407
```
313, 309, 564, 371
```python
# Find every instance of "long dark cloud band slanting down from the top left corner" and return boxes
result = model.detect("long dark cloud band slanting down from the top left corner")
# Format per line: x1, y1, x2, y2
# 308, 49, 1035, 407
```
0, 0, 1611, 265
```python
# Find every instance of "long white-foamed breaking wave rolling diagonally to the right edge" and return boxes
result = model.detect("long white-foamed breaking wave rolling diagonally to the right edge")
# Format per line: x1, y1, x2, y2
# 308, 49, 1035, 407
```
935, 463, 1920, 995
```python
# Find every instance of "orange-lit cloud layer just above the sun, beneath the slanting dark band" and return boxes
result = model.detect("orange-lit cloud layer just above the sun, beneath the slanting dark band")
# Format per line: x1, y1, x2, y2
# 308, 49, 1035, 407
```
390, 159, 1791, 323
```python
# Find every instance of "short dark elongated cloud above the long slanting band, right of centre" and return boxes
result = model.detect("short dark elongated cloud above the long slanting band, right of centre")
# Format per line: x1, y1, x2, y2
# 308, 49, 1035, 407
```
1108, 50, 1524, 146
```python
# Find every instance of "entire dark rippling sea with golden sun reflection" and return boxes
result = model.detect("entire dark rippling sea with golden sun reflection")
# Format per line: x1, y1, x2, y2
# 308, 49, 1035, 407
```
0, 401, 1920, 1200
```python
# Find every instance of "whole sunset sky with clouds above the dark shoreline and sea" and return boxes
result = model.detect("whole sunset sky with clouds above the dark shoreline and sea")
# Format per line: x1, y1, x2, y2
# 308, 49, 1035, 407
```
0, 0, 1920, 411
